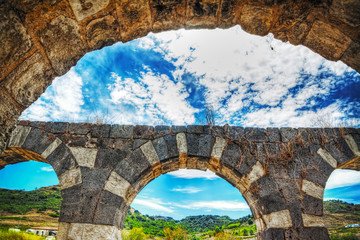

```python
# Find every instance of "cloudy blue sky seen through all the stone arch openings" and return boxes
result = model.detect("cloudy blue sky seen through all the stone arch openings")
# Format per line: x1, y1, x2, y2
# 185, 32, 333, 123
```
0, 26, 360, 218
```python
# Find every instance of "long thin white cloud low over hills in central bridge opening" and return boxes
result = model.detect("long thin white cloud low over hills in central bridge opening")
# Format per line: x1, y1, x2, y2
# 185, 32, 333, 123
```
174, 201, 249, 211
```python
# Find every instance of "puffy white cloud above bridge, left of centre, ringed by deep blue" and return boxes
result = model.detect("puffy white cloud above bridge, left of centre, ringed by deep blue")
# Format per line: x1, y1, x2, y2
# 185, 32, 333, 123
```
109, 69, 198, 125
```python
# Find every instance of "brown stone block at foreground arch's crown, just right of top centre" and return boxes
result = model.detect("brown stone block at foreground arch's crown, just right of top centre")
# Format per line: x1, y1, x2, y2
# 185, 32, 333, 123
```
186, 0, 219, 28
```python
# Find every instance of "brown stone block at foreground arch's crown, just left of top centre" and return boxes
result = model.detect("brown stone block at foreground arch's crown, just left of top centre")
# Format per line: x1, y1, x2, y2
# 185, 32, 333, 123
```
150, 0, 187, 31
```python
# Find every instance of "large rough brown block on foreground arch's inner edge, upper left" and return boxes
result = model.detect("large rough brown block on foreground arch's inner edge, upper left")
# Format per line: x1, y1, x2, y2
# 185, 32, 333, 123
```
38, 16, 85, 75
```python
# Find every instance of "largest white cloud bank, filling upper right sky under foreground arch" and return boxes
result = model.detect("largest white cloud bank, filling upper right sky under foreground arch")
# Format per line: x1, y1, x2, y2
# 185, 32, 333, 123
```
139, 26, 358, 127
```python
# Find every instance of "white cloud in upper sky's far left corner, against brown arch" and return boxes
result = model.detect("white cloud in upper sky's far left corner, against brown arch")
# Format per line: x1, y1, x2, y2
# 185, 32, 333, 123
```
20, 68, 84, 121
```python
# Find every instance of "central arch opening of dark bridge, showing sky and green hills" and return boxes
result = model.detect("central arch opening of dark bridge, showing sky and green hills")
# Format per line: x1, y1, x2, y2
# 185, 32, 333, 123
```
124, 169, 256, 237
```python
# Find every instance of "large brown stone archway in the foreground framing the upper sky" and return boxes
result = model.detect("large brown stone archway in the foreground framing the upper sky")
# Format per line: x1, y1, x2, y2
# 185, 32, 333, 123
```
0, 0, 360, 156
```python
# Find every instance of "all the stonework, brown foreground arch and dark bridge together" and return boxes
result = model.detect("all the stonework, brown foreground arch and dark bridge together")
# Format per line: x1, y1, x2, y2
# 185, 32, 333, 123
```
0, 0, 360, 239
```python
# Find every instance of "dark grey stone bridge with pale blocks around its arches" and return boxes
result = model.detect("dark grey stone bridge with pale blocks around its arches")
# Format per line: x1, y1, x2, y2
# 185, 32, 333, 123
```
0, 121, 360, 240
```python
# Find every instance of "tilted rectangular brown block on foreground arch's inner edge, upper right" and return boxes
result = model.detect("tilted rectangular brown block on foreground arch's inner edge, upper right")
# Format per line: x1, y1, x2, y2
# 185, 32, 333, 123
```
304, 21, 351, 61
